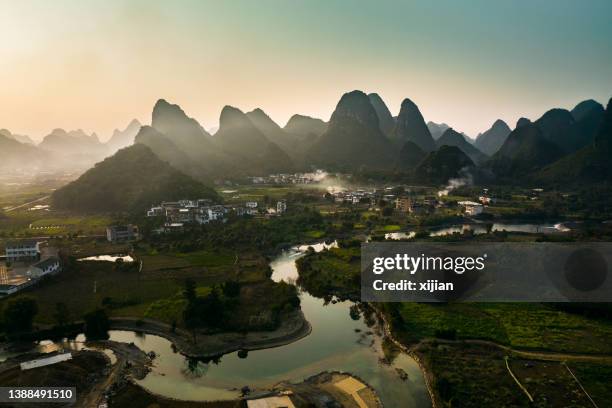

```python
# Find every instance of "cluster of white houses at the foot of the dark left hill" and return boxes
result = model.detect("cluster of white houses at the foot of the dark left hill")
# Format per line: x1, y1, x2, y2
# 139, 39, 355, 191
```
147, 199, 287, 232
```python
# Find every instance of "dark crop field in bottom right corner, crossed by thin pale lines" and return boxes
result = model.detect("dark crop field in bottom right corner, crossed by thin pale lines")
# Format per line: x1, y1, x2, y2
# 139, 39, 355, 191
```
419, 344, 612, 407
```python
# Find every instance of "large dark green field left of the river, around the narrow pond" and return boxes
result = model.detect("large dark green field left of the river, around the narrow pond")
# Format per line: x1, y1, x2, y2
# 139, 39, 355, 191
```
0, 239, 292, 328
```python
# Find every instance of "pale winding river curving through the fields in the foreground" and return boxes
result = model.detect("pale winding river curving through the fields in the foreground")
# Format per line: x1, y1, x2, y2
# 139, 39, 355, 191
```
3, 243, 431, 407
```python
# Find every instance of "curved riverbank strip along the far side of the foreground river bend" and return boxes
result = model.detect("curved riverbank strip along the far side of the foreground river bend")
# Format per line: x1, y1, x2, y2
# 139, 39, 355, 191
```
110, 310, 312, 359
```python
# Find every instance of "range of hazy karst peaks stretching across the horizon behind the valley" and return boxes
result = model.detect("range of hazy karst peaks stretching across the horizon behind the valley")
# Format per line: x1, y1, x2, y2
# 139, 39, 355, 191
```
0, 90, 609, 190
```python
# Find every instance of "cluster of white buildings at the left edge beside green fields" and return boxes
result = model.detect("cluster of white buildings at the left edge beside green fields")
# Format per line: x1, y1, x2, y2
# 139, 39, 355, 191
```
0, 240, 61, 296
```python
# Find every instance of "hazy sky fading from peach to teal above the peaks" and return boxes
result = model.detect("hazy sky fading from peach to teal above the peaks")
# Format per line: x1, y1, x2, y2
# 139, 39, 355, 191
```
0, 0, 612, 139
